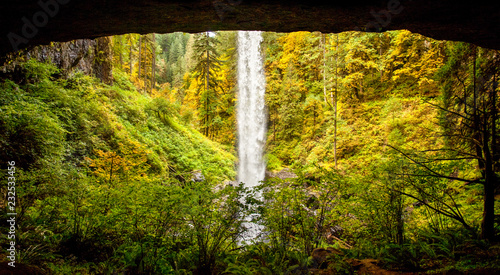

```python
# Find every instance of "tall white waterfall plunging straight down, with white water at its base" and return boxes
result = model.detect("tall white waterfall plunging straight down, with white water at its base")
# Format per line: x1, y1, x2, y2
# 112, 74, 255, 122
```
237, 31, 267, 241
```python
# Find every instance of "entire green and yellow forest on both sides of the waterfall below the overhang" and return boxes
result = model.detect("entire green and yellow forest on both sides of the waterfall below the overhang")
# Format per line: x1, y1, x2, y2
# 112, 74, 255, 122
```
0, 30, 500, 275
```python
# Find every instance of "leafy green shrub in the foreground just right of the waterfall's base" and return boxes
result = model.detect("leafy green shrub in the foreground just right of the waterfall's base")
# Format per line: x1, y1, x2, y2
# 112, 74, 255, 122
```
261, 172, 339, 257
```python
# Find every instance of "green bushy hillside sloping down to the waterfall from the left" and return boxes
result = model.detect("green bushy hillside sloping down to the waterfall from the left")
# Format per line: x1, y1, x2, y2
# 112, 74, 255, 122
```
0, 60, 240, 274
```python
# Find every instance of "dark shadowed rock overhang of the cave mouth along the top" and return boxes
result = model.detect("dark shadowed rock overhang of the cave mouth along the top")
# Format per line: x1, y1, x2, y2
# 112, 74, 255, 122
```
0, 0, 500, 53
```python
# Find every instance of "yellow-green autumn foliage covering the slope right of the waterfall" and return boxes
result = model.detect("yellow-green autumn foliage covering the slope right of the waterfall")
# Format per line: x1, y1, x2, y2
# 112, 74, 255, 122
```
263, 31, 498, 270
